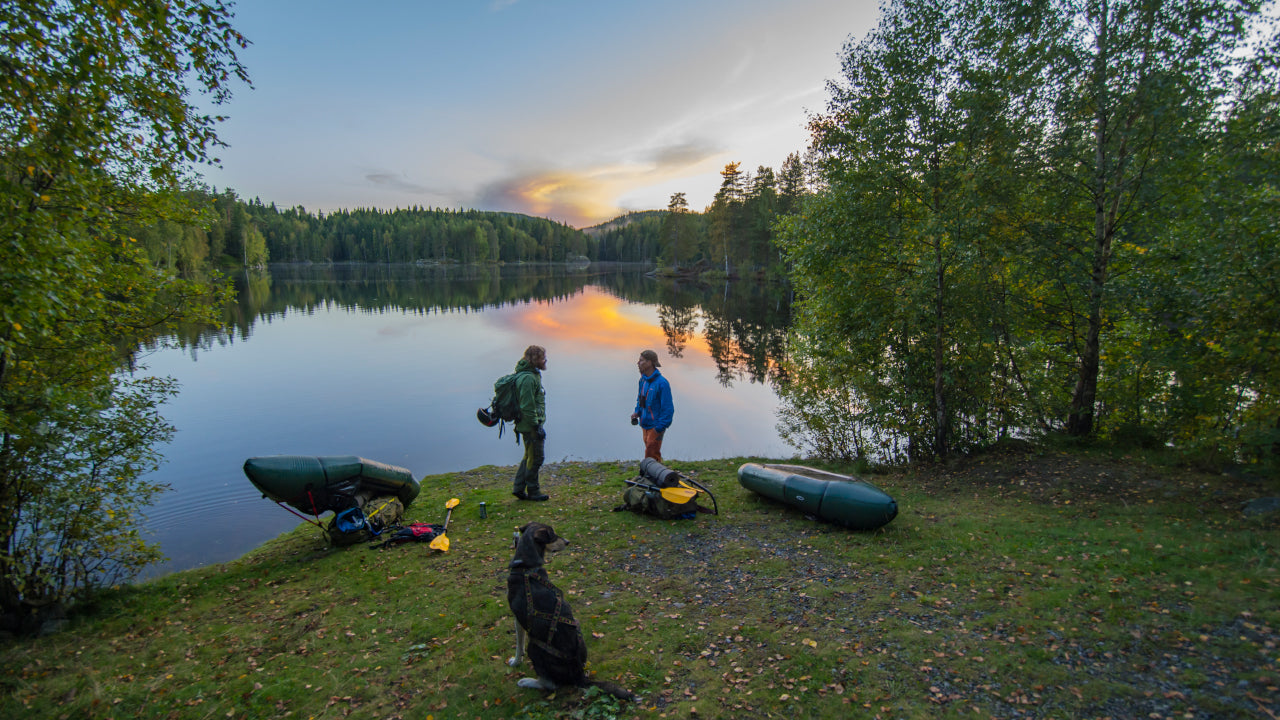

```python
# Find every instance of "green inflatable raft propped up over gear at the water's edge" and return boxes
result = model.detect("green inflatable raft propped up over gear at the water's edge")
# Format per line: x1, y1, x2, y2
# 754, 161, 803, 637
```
244, 455, 420, 515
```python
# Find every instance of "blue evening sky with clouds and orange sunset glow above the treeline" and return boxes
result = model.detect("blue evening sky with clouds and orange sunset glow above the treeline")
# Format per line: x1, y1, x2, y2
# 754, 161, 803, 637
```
202, 0, 878, 228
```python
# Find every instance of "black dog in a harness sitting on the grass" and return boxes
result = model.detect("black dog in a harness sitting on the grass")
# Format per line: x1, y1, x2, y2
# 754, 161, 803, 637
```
507, 523, 635, 700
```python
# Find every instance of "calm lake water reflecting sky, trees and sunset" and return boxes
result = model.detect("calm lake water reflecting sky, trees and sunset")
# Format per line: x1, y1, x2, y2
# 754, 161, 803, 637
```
141, 265, 795, 577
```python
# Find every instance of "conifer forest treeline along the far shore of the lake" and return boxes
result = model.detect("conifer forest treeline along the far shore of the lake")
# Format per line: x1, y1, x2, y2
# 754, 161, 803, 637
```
140, 154, 804, 275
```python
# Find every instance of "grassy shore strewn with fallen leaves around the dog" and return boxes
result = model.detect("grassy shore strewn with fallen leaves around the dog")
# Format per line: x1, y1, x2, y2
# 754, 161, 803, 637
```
0, 447, 1280, 720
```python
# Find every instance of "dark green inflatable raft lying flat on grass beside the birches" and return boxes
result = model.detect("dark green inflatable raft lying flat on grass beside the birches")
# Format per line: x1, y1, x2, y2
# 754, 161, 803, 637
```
737, 462, 897, 530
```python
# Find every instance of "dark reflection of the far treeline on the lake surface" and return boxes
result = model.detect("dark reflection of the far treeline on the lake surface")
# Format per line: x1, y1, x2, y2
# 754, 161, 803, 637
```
156, 264, 791, 386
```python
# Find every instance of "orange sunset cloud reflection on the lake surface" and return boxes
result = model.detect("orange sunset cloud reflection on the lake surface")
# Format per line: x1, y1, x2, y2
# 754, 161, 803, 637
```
507, 287, 709, 355
